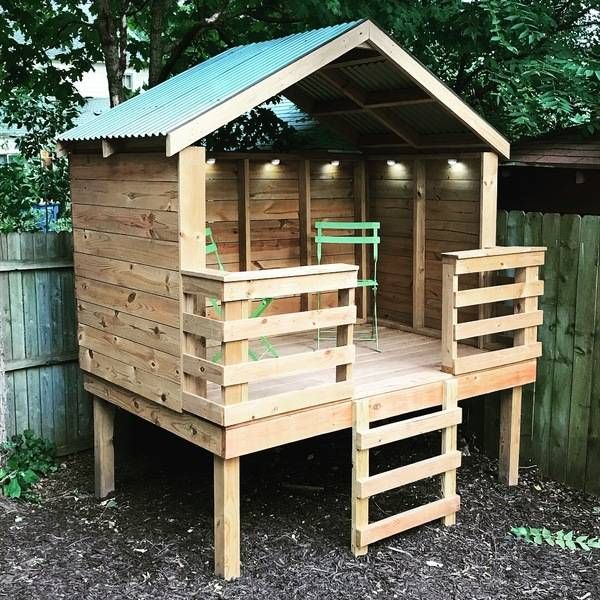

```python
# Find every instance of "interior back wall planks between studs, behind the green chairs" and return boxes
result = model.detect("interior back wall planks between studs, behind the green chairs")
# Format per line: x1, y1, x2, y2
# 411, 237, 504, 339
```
206, 156, 354, 314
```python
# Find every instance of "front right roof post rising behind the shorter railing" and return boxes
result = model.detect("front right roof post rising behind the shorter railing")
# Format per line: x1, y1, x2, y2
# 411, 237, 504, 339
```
477, 152, 498, 348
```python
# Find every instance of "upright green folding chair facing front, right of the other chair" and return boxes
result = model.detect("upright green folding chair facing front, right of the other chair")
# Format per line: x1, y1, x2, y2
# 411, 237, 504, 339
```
315, 221, 381, 352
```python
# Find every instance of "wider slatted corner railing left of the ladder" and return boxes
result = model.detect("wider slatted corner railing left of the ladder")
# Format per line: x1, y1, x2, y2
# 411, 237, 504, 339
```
181, 264, 358, 426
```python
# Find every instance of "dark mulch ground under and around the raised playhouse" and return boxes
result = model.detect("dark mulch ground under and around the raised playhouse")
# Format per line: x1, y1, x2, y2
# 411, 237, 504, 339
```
0, 422, 600, 600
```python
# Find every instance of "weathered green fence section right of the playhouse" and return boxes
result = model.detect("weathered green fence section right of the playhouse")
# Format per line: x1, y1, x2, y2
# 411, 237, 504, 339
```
471, 211, 600, 494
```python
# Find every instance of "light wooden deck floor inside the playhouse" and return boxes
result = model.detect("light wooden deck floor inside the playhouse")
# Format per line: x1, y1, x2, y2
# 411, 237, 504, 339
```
209, 327, 476, 399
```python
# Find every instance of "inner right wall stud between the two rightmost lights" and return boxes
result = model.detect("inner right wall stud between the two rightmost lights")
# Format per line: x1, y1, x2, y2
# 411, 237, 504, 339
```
412, 159, 426, 329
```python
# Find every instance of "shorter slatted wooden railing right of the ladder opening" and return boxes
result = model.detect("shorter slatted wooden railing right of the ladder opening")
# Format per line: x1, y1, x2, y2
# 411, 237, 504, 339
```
442, 246, 546, 375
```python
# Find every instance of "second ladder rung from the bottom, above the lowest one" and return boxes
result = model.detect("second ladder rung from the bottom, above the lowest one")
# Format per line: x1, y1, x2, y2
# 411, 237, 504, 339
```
356, 450, 461, 498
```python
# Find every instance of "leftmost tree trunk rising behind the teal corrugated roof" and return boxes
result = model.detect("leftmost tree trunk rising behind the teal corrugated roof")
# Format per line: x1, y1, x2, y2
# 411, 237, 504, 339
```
97, 0, 127, 106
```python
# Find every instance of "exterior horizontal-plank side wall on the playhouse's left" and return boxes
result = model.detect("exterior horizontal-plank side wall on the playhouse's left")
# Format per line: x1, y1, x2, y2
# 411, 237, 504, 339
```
70, 153, 180, 409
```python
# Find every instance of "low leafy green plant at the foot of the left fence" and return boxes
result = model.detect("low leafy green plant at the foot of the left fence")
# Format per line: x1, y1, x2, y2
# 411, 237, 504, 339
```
0, 429, 56, 500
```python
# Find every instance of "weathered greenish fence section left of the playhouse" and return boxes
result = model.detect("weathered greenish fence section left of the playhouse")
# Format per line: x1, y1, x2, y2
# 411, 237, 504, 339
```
0, 232, 91, 454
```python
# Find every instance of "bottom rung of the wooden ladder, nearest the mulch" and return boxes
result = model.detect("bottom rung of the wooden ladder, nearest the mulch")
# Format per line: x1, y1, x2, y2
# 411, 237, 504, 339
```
356, 495, 460, 546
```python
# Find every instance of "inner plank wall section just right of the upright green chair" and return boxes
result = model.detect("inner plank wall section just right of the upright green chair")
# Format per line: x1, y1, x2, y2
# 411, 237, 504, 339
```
367, 160, 414, 325
